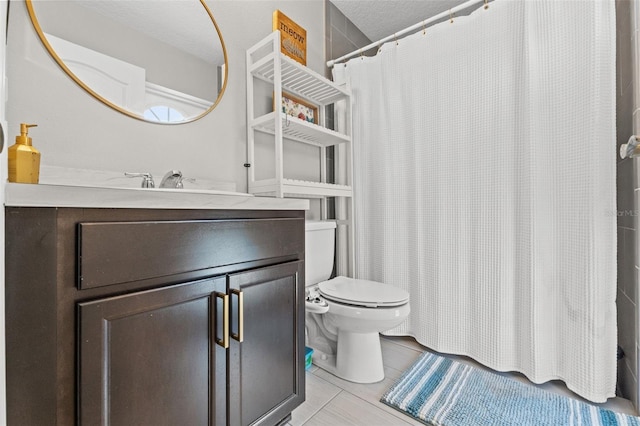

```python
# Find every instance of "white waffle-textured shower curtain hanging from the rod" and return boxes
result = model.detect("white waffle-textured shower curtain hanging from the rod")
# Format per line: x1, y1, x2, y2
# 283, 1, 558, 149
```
334, 0, 617, 402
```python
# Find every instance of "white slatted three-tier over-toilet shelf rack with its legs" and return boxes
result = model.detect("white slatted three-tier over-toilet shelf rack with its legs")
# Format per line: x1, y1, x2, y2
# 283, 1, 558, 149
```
246, 31, 354, 276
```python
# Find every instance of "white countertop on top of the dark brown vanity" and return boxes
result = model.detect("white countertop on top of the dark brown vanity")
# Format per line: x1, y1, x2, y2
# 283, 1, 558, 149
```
5, 183, 309, 210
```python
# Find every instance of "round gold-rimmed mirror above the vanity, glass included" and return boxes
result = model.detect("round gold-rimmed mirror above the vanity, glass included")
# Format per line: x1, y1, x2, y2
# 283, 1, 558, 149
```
26, 0, 227, 124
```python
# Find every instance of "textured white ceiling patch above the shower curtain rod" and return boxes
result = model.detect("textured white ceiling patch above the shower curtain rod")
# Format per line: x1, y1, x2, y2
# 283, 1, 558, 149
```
330, 0, 467, 42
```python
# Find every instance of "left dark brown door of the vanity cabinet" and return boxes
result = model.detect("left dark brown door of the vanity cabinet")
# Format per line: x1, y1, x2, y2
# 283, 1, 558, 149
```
78, 277, 228, 426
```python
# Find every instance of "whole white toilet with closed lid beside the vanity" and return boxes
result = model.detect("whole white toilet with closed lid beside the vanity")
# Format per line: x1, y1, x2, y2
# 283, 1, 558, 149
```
305, 221, 410, 383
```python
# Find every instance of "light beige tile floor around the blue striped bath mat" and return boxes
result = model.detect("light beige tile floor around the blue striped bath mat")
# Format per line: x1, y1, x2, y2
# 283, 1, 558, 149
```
289, 337, 636, 426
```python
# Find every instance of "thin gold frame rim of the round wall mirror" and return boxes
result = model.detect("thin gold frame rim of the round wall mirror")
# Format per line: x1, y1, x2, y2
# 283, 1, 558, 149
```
25, 0, 229, 125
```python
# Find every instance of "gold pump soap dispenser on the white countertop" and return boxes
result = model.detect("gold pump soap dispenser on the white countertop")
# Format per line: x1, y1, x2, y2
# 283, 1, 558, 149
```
8, 123, 40, 183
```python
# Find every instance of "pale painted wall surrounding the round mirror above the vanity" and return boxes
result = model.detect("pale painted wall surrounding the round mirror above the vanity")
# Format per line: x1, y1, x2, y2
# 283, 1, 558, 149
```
7, 0, 324, 191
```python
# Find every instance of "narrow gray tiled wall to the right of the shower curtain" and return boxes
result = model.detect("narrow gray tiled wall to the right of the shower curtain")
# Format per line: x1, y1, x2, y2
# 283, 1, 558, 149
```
616, 0, 638, 409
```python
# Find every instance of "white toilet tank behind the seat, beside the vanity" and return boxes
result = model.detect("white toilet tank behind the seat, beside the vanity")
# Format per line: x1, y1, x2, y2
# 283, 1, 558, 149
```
304, 220, 336, 286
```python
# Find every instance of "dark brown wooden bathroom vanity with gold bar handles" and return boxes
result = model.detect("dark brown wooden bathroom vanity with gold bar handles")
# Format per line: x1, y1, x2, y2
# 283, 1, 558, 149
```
5, 185, 308, 425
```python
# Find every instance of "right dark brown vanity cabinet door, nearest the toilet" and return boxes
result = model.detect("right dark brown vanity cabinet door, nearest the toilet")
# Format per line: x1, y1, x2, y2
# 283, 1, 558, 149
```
228, 262, 305, 426
